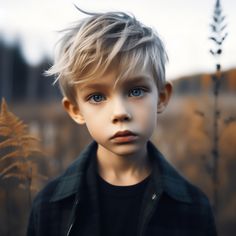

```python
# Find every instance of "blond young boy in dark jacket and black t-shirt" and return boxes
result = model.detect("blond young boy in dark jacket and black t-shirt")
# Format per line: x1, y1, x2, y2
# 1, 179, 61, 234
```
28, 9, 216, 236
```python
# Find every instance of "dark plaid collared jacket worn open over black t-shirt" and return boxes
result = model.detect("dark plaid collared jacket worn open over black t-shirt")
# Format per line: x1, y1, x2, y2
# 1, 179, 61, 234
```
27, 142, 217, 236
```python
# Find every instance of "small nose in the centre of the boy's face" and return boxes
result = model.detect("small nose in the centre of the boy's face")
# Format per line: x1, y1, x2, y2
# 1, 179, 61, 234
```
111, 98, 132, 123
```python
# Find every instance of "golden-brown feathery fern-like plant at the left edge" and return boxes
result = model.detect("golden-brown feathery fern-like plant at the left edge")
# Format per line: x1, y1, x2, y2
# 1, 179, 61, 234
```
0, 98, 46, 191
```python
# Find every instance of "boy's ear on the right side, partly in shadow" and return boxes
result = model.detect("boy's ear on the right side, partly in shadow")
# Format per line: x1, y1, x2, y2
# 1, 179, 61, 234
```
157, 82, 173, 113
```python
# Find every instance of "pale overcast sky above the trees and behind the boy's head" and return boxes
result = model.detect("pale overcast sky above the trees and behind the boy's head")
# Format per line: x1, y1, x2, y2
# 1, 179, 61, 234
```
0, 0, 236, 79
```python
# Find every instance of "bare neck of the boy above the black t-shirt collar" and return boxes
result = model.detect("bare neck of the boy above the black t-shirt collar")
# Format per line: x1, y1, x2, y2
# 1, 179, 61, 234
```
97, 145, 151, 186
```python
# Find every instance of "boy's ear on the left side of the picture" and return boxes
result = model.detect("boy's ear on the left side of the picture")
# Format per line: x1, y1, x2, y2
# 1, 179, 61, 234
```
62, 97, 85, 125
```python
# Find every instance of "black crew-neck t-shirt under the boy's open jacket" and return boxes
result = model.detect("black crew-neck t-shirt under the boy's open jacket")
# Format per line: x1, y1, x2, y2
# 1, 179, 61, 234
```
98, 175, 149, 236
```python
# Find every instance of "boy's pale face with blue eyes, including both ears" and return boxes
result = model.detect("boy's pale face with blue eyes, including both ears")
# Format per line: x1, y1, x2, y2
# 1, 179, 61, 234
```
63, 65, 171, 156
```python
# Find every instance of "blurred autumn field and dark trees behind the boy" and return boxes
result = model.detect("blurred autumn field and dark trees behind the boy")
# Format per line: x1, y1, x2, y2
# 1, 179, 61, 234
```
0, 1, 236, 236
